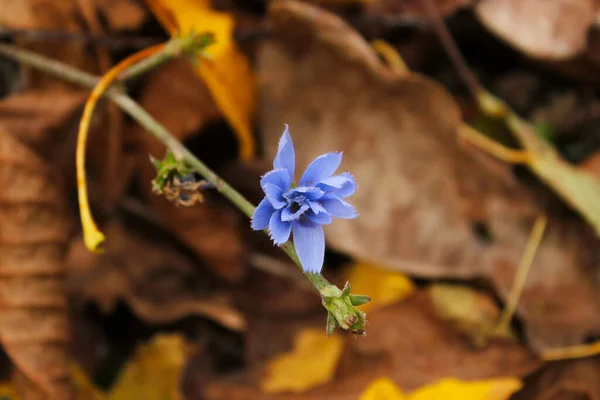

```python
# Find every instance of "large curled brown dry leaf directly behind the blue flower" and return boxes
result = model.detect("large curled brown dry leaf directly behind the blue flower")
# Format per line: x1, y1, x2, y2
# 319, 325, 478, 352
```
259, 1, 600, 349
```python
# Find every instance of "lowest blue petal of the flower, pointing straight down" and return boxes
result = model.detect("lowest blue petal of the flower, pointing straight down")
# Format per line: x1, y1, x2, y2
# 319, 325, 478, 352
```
292, 220, 325, 273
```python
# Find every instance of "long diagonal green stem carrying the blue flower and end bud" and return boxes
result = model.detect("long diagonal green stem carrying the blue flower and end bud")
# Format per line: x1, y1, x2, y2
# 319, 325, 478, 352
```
0, 38, 364, 333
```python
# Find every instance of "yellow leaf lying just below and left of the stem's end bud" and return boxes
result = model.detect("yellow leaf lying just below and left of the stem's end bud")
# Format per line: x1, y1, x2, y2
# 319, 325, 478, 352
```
261, 329, 344, 393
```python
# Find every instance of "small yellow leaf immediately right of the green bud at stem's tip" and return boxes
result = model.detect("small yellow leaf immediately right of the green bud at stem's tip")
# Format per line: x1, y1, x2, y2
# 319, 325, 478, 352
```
347, 262, 415, 312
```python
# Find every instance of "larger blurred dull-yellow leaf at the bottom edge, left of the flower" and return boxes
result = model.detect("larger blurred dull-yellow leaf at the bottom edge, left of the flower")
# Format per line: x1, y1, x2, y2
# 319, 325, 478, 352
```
108, 334, 188, 400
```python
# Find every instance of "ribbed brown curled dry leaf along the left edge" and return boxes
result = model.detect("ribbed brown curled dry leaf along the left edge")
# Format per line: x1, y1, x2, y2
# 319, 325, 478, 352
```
0, 129, 71, 399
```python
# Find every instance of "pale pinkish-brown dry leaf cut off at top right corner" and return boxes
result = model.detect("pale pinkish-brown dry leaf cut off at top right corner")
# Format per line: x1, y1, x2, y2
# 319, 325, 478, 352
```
475, 0, 597, 60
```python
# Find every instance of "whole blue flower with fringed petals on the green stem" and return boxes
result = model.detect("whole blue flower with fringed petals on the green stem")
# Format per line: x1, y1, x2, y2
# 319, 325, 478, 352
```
252, 124, 358, 273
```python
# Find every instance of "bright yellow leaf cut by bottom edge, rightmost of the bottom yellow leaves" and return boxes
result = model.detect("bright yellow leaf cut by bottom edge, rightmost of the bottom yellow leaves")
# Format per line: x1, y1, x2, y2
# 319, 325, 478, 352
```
408, 377, 523, 400
